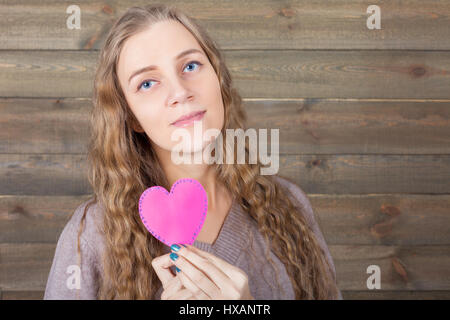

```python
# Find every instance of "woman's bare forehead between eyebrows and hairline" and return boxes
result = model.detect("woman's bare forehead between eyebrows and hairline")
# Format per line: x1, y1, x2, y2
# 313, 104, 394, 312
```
118, 20, 203, 76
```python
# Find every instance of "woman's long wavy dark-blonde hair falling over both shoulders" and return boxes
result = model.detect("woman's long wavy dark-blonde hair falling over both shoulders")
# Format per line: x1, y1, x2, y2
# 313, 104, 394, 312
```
78, 4, 338, 299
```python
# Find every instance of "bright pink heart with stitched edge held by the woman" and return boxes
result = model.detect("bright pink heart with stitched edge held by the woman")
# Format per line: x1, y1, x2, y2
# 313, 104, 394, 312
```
139, 178, 208, 246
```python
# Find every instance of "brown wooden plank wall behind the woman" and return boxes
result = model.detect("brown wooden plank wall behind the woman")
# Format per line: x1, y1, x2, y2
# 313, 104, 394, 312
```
0, 0, 450, 299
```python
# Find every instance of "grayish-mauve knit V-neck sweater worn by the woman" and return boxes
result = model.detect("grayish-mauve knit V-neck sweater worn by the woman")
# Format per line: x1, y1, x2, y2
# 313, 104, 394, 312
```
44, 176, 342, 300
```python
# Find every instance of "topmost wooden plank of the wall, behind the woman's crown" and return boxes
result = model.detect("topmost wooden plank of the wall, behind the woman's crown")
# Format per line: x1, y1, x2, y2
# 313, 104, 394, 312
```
0, 0, 450, 50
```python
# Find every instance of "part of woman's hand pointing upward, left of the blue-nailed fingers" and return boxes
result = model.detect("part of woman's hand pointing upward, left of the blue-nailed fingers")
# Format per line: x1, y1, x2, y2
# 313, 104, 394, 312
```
152, 253, 196, 300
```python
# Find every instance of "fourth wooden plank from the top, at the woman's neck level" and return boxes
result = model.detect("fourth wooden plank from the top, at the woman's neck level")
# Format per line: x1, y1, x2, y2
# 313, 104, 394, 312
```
0, 154, 450, 195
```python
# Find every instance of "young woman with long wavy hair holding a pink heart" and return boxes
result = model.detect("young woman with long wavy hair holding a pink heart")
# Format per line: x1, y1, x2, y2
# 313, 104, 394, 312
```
45, 5, 342, 299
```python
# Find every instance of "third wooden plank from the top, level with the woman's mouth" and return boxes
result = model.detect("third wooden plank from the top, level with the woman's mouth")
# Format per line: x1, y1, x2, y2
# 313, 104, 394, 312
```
0, 98, 450, 154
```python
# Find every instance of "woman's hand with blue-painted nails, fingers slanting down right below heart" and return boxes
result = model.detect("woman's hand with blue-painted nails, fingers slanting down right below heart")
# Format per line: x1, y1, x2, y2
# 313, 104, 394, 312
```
170, 245, 254, 300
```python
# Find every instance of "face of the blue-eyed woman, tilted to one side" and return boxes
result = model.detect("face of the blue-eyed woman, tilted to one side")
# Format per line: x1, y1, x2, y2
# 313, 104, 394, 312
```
117, 20, 224, 156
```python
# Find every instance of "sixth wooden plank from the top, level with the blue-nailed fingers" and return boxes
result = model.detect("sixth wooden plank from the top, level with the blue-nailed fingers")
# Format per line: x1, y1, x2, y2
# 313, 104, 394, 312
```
0, 243, 450, 291
